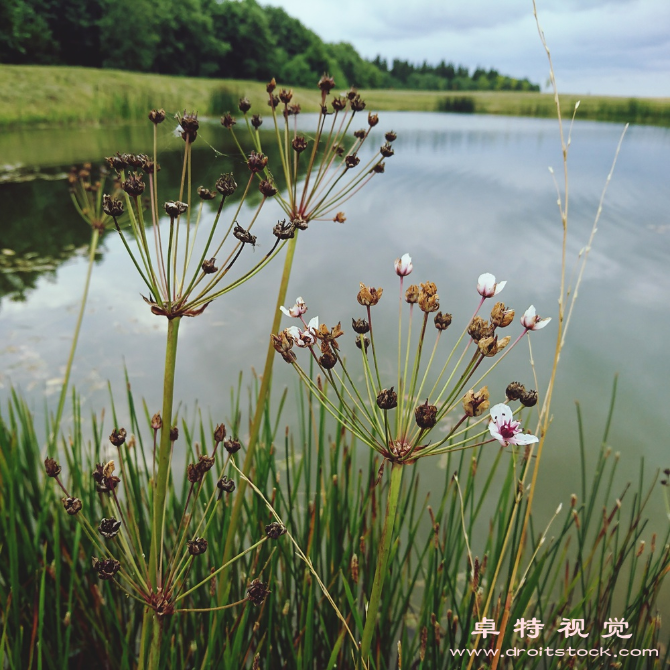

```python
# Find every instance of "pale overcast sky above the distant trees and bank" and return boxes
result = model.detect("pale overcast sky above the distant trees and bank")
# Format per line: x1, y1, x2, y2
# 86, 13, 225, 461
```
261, 0, 670, 97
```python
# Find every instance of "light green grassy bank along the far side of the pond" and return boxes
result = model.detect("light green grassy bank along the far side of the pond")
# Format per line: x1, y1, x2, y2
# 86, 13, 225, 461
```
0, 65, 670, 128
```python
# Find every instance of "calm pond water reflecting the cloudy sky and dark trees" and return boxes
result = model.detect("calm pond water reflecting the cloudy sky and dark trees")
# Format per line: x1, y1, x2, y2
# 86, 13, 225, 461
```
0, 113, 670, 584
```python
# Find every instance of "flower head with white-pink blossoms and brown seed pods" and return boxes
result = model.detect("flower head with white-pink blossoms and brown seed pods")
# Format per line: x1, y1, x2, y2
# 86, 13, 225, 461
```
272, 254, 550, 474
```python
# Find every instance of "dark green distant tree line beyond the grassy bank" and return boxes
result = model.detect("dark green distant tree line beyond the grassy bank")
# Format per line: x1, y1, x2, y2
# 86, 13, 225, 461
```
0, 0, 539, 91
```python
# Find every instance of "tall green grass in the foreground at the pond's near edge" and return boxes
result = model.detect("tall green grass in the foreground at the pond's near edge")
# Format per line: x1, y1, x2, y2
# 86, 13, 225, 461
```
0, 381, 670, 670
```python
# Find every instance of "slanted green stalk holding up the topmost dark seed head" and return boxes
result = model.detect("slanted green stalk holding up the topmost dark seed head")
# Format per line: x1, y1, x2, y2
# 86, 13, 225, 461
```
202, 238, 298, 669
